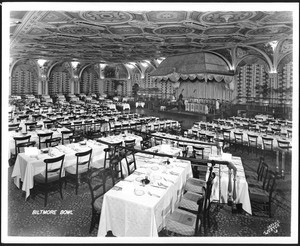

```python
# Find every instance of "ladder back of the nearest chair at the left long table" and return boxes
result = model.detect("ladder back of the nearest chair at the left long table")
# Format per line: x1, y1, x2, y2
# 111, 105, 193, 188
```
44, 155, 65, 184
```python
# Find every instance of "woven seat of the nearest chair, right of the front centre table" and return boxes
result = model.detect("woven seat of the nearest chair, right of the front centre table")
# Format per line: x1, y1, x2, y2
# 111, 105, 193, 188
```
166, 209, 197, 236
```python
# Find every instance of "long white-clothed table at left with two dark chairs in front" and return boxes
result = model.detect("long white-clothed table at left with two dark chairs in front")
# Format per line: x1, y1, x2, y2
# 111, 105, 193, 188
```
12, 140, 107, 199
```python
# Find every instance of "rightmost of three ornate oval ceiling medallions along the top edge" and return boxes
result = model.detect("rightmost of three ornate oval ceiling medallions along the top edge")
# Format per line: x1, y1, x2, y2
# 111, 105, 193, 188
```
199, 11, 256, 24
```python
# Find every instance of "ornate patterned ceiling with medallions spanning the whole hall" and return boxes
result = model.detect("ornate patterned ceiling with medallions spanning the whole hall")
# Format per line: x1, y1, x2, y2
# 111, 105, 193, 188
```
10, 9, 293, 64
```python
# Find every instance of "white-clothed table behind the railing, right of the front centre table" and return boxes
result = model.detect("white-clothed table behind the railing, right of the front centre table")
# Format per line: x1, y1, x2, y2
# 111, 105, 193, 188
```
209, 155, 252, 214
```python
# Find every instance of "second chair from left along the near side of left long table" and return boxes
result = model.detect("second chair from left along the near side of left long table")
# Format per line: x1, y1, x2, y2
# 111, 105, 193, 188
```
65, 149, 93, 195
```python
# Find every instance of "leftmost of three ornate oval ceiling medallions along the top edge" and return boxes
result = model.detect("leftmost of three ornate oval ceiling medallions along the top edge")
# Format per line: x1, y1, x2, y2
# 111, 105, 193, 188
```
80, 11, 133, 24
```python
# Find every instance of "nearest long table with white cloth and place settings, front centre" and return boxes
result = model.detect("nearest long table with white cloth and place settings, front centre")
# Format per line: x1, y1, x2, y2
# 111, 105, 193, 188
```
98, 157, 192, 237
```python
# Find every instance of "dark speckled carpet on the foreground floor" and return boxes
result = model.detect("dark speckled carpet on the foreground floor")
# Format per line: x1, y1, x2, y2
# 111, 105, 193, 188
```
8, 145, 291, 237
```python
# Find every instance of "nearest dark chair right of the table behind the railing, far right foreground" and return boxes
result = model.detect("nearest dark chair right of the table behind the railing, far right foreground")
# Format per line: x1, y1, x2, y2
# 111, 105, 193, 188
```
249, 170, 276, 218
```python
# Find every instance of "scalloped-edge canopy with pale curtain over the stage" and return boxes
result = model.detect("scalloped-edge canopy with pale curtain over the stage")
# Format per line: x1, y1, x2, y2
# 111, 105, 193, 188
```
150, 52, 234, 100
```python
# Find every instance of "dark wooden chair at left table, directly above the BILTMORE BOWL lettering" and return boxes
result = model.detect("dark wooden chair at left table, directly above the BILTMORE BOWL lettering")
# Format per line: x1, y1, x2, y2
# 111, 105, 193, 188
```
32, 155, 65, 207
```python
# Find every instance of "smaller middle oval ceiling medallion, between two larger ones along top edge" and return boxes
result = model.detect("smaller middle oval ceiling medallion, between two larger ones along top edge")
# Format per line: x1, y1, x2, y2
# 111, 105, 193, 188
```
146, 11, 187, 22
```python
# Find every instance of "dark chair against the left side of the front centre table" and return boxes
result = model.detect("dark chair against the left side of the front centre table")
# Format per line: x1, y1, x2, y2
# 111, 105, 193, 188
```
87, 169, 109, 233
